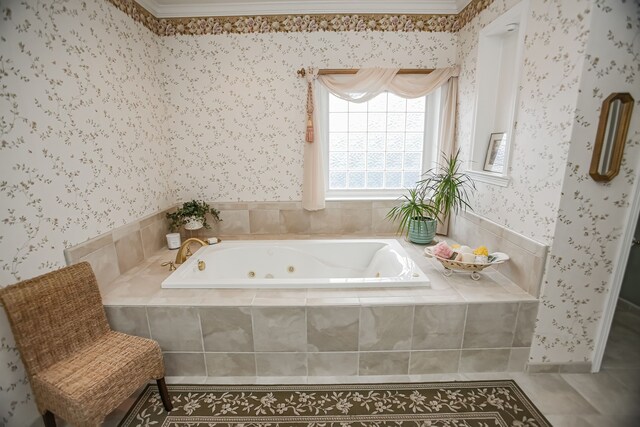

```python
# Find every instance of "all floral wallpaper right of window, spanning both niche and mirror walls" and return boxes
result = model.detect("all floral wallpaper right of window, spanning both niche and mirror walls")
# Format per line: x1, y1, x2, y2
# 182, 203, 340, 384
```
457, 0, 640, 364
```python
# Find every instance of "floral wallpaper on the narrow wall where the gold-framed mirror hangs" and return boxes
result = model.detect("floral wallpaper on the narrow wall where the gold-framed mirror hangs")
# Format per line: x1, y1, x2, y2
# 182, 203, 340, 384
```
531, 0, 640, 363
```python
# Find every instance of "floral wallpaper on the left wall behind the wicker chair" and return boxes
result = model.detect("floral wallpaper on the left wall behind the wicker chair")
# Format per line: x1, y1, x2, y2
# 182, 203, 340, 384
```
0, 0, 173, 426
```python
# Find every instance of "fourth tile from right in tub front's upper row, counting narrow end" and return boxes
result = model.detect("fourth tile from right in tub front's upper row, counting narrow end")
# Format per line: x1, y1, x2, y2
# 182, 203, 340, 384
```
359, 306, 413, 352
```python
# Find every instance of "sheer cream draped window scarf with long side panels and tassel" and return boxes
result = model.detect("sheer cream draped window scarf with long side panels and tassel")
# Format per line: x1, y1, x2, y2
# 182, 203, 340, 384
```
302, 66, 459, 216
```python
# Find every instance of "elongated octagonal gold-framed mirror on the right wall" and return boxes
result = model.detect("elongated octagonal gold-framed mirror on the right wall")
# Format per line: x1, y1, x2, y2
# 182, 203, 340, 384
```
589, 92, 633, 182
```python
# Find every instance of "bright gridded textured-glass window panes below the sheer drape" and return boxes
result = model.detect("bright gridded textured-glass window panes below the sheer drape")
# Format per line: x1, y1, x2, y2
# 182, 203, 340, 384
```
326, 92, 430, 198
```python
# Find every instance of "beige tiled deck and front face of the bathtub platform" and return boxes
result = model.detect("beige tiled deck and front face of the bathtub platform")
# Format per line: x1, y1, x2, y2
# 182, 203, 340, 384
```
100, 236, 538, 378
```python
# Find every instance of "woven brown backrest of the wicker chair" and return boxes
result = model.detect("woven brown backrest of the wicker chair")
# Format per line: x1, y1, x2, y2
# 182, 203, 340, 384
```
0, 262, 110, 377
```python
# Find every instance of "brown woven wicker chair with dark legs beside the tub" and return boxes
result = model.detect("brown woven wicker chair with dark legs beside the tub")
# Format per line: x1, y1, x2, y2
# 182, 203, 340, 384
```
0, 262, 172, 427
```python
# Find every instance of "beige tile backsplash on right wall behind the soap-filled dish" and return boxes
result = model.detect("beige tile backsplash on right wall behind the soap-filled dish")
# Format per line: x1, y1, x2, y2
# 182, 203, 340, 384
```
449, 211, 548, 297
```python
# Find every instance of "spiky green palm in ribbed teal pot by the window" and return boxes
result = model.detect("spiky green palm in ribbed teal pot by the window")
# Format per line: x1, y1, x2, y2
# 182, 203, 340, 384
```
387, 150, 475, 245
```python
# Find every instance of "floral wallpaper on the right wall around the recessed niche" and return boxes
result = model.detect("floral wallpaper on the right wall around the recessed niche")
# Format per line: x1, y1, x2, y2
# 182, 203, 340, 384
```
457, 0, 590, 245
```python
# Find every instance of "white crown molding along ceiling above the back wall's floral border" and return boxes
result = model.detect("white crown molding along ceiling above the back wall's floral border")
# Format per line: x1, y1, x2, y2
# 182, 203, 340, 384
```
136, 0, 470, 18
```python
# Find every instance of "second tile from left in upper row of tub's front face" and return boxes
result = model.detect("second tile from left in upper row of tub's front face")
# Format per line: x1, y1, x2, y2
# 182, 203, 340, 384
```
147, 307, 203, 352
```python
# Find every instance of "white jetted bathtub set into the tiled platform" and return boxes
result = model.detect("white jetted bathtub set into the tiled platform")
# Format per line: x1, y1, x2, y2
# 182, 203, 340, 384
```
162, 239, 429, 289
